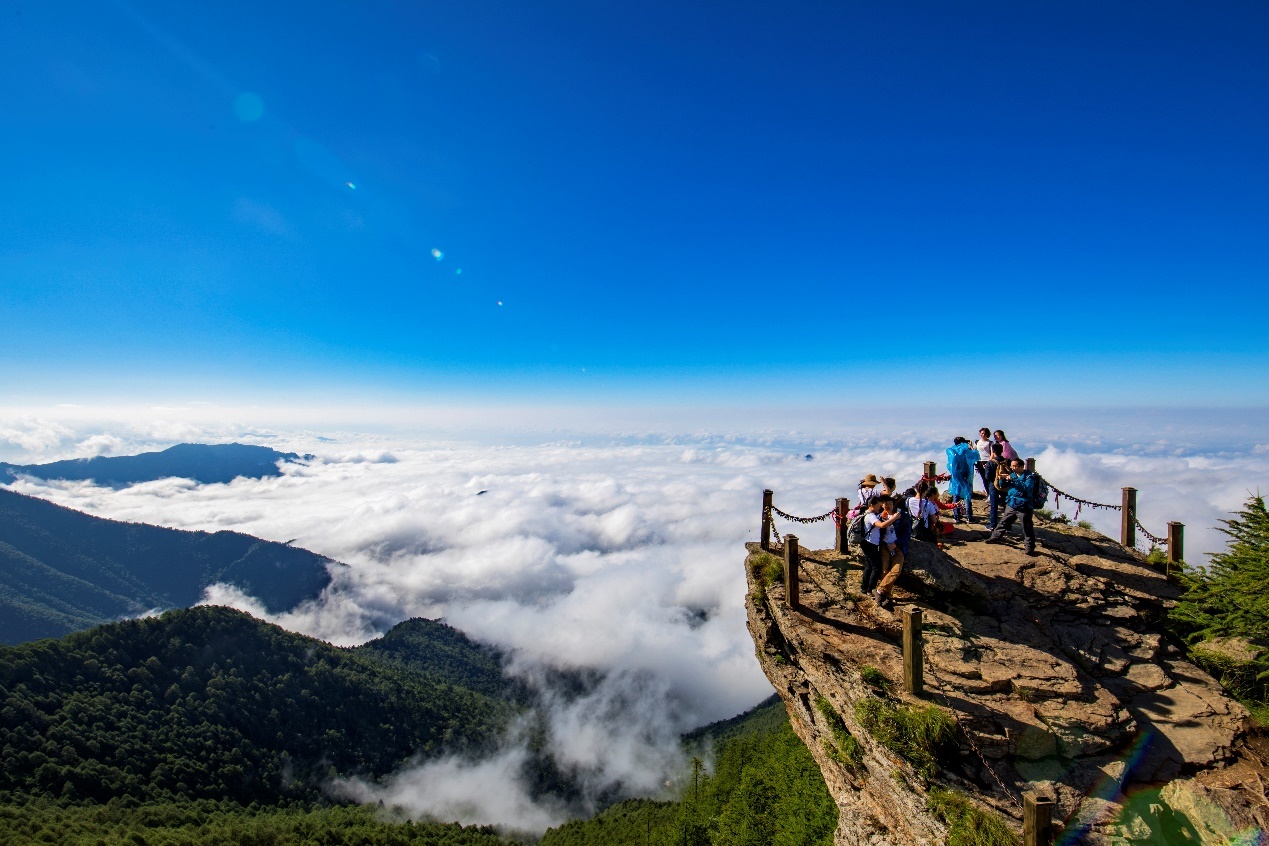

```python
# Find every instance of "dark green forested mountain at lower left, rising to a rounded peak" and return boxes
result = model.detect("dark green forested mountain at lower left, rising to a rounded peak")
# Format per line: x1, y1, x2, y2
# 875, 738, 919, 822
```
0, 606, 513, 804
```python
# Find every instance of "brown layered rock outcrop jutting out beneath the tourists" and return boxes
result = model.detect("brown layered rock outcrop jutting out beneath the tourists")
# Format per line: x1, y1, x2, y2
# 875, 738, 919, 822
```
746, 524, 1269, 846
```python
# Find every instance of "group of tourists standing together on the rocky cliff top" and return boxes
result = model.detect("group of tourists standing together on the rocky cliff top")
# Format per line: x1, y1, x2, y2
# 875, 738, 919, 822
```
848, 429, 1047, 608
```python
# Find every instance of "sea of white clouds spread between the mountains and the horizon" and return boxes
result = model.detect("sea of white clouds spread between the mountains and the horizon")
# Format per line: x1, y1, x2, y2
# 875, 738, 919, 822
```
0, 412, 1269, 831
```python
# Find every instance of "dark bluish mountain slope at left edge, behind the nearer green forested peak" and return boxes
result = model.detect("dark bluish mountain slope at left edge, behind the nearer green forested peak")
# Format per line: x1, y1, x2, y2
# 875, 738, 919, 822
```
0, 488, 334, 643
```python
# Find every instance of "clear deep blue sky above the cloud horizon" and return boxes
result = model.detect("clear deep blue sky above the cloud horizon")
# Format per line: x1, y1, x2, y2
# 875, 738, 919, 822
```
0, 0, 1269, 405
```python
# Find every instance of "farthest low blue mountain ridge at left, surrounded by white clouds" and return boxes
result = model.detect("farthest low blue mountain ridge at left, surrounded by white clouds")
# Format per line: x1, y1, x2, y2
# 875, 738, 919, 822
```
0, 444, 313, 487
